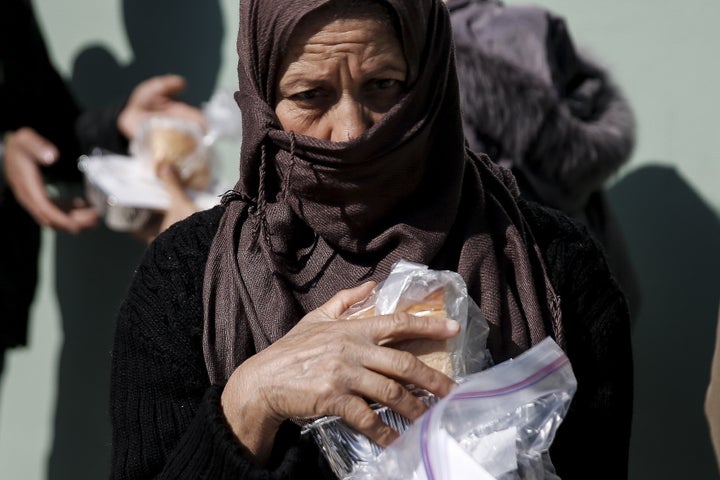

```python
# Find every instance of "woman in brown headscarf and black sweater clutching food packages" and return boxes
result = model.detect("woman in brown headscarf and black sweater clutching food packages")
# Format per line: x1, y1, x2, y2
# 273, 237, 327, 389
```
112, 0, 632, 479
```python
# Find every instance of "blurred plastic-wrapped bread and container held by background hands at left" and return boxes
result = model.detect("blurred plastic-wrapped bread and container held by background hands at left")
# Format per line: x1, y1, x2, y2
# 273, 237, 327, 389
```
78, 91, 242, 231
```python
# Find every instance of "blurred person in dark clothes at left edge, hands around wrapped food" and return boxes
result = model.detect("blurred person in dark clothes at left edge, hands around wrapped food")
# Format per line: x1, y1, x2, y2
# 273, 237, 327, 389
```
0, 0, 203, 386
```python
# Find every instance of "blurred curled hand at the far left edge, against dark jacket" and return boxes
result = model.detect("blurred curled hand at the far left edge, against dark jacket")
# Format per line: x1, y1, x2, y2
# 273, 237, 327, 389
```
4, 128, 99, 233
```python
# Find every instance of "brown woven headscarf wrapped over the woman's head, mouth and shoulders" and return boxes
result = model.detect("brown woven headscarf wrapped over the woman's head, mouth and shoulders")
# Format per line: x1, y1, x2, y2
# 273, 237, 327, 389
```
203, 0, 561, 383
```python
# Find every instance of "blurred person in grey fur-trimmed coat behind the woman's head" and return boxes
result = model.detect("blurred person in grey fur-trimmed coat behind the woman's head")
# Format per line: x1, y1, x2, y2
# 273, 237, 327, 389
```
446, 0, 641, 322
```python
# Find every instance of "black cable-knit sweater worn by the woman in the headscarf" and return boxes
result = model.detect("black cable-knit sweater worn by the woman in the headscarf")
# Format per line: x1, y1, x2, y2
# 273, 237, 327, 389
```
111, 201, 632, 479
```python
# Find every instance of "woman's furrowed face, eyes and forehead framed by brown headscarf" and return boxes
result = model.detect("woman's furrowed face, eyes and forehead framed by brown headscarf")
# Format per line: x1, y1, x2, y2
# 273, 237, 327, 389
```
275, 13, 407, 142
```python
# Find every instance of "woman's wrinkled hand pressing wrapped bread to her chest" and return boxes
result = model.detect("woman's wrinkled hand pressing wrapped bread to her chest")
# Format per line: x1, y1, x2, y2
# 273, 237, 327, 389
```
222, 282, 460, 464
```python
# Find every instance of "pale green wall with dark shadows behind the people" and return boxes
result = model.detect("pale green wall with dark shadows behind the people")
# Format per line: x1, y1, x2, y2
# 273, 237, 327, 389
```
0, 0, 720, 480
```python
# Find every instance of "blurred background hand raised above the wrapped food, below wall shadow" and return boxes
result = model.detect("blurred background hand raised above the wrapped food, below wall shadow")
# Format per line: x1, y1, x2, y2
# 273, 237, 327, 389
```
117, 75, 205, 139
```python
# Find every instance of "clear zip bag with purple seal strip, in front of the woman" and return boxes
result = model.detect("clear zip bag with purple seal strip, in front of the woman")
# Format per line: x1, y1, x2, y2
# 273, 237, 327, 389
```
344, 338, 577, 480
